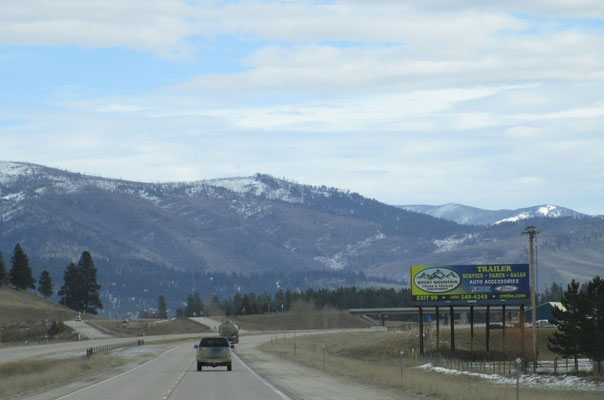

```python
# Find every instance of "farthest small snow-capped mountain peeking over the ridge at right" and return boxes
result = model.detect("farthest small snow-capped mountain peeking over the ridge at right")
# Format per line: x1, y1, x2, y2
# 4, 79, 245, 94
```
400, 203, 586, 225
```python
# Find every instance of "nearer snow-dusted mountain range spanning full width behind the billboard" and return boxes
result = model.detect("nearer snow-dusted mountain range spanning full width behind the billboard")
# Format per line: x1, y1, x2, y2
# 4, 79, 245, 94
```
0, 162, 604, 312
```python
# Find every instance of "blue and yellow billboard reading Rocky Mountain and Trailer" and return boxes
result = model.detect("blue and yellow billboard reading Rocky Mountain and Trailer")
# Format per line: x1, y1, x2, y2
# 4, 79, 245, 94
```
411, 264, 530, 306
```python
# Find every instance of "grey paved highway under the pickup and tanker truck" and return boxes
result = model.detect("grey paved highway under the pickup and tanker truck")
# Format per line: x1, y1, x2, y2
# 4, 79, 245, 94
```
9, 332, 415, 400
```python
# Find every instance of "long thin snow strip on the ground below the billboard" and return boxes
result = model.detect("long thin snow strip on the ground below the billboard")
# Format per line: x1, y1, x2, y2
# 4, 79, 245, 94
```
417, 363, 604, 391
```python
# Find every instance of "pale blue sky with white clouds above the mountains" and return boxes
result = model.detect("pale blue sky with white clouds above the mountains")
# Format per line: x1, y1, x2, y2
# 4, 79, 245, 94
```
0, 0, 604, 214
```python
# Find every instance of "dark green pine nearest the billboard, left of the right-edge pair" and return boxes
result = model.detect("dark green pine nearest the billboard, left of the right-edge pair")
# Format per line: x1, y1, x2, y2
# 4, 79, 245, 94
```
547, 279, 589, 371
